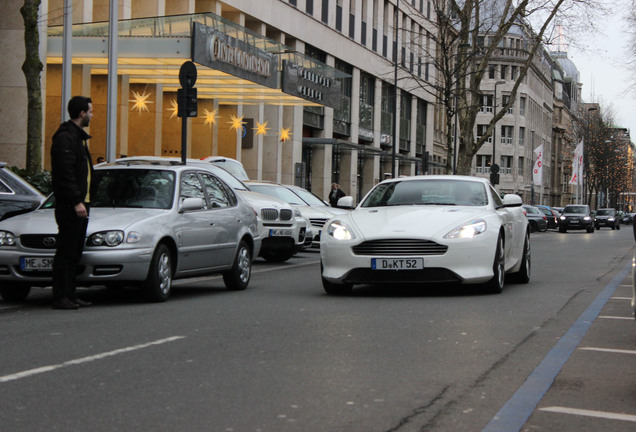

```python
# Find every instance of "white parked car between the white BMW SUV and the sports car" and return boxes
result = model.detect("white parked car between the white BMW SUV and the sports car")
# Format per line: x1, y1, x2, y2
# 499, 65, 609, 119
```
245, 181, 348, 247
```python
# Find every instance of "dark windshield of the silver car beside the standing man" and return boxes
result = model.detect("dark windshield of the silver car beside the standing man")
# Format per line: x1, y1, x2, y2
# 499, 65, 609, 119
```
91, 169, 175, 209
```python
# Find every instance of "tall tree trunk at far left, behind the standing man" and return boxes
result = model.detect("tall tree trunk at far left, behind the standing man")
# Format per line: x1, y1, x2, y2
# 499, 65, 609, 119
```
20, 0, 43, 175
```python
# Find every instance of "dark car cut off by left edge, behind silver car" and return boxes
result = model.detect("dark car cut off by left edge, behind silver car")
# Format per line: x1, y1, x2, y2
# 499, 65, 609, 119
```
0, 162, 46, 220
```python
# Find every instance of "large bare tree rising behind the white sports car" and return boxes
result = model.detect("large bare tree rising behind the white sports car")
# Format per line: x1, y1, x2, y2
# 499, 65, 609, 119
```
392, 0, 601, 174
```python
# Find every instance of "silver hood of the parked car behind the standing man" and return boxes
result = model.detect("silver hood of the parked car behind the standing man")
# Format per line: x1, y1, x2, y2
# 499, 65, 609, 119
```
0, 208, 168, 235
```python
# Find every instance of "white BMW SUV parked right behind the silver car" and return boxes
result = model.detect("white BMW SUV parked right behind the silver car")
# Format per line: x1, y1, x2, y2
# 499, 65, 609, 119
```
117, 156, 312, 262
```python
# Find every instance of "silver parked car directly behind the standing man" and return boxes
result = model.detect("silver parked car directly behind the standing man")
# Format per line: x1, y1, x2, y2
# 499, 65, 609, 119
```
0, 163, 261, 301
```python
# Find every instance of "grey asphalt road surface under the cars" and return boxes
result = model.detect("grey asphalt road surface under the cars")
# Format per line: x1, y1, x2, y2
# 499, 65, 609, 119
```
0, 227, 636, 432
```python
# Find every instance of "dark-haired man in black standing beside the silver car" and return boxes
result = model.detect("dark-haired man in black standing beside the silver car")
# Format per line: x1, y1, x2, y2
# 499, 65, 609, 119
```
51, 96, 93, 309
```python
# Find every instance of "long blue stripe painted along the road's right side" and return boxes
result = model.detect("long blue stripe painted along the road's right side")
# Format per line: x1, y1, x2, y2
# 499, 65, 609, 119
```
482, 262, 631, 432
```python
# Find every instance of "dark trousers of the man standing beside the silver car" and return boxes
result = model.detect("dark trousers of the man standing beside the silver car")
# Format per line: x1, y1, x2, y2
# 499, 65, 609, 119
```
53, 206, 88, 300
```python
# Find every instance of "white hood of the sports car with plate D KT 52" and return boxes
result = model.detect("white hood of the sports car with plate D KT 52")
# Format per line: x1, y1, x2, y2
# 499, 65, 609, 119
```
342, 206, 491, 239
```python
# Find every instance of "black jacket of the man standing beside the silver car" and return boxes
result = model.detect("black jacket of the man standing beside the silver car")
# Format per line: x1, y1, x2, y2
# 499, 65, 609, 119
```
51, 120, 93, 206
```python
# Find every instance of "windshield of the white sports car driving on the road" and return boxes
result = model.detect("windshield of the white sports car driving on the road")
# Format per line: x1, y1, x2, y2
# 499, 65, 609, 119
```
362, 179, 488, 207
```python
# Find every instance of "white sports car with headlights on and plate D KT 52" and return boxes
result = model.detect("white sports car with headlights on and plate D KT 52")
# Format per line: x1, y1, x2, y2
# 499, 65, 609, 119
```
320, 176, 530, 294
